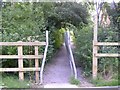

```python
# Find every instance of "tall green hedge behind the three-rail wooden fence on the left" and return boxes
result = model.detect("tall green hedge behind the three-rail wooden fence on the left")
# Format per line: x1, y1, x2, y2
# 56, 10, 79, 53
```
0, 2, 62, 82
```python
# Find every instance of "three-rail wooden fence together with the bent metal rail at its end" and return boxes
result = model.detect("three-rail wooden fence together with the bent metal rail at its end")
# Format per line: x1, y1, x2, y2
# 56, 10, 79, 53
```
0, 31, 48, 83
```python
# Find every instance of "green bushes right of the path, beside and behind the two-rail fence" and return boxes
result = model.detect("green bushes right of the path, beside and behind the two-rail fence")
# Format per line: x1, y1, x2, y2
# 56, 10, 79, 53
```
74, 25, 119, 79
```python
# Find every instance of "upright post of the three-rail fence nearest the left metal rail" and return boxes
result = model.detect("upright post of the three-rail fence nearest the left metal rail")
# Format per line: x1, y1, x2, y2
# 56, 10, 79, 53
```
35, 41, 39, 83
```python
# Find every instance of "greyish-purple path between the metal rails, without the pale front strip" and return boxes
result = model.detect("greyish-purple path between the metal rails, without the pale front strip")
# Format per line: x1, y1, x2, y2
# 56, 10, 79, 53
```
43, 46, 71, 84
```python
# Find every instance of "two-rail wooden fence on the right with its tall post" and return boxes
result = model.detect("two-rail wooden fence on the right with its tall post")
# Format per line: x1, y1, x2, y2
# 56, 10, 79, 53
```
92, 7, 120, 79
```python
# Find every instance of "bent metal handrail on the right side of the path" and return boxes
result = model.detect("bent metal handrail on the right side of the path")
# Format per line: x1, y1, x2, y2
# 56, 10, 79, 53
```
65, 31, 77, 79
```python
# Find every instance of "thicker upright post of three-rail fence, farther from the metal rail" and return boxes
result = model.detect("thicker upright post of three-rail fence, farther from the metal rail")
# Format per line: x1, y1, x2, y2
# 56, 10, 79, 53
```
18, 41, 24, 80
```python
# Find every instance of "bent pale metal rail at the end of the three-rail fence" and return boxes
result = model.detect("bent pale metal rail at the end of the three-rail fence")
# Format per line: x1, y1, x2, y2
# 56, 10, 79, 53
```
40, 31, 48, 84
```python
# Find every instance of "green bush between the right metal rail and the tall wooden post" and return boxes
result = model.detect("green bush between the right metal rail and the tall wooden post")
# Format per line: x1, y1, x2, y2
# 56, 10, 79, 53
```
75, 26, 93, 76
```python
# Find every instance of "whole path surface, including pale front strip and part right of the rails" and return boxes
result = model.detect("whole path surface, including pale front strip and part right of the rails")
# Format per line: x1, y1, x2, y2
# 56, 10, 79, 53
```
43, 46, 93, 88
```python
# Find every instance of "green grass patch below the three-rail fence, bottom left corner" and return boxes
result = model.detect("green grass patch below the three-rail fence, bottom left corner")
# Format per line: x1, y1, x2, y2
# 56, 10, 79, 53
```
0, 76, 29, 88
